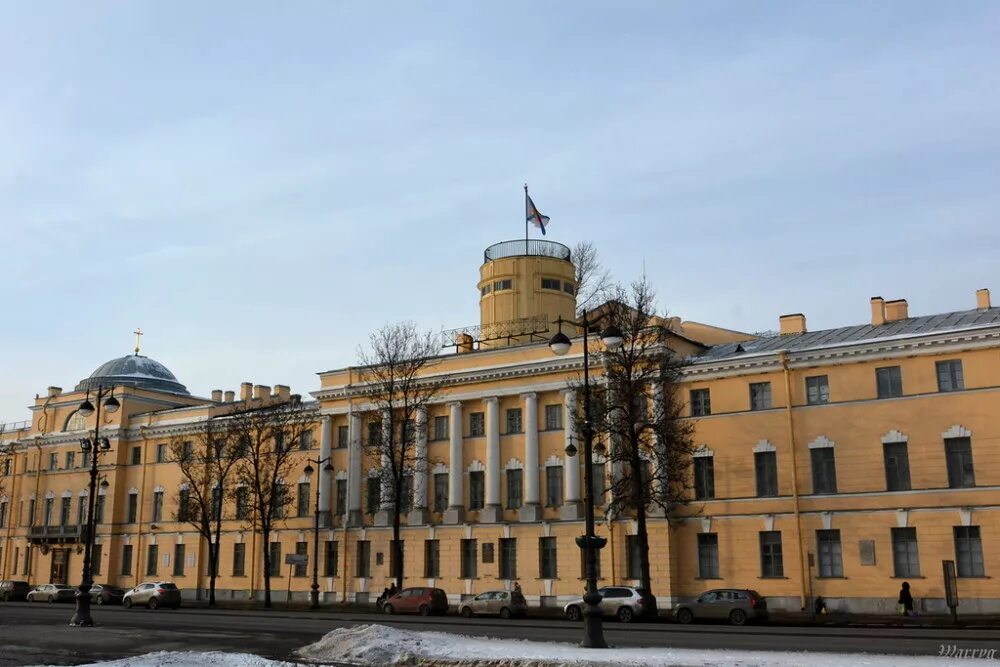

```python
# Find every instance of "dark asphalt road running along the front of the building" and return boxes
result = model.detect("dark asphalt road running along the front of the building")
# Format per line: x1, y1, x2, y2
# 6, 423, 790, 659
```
0, 602, 1000, 667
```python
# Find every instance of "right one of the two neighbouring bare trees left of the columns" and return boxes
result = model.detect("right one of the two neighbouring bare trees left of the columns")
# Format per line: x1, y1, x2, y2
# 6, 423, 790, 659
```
229, 395, 313, 608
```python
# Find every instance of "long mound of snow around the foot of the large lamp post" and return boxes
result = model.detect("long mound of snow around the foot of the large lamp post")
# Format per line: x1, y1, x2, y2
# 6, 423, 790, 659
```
296, 625, 965, 667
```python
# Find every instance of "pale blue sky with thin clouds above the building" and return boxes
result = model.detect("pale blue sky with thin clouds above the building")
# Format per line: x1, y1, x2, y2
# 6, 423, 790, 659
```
0, 0, 1000, 421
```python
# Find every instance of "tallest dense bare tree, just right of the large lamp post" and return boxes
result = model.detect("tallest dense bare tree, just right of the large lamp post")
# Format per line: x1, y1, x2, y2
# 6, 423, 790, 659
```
592, 277, 694, 609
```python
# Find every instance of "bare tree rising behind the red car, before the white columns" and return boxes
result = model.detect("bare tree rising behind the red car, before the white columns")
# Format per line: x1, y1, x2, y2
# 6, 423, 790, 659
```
358, 322, 441, 587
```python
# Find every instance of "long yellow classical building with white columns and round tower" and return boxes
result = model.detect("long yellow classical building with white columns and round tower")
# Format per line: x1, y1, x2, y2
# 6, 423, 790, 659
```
0, 241, 1000, 613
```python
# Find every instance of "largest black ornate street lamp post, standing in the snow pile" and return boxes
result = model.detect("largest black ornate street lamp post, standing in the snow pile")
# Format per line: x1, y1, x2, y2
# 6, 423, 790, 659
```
549, 311, 622, 648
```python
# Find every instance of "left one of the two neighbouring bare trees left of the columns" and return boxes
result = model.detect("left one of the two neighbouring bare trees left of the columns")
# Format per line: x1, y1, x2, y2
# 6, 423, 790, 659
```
170, 417, 240, 607
